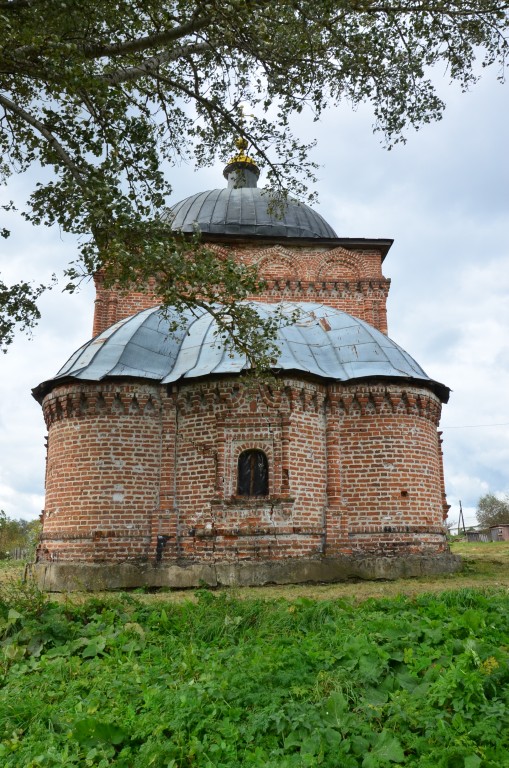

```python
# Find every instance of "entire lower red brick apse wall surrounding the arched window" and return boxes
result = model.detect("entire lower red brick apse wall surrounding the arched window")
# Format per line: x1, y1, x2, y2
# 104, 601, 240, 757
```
40, 378, 445, 562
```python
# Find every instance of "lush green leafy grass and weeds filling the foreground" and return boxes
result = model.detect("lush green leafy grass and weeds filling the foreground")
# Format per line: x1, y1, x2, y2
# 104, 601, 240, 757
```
0, 584, 509, 768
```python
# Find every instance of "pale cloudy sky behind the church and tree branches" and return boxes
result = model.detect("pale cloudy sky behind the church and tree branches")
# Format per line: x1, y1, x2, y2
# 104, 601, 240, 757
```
0, 70, 509, 527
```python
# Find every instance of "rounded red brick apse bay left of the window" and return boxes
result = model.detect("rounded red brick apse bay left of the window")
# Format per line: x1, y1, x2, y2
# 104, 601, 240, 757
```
42, 383, 161, 561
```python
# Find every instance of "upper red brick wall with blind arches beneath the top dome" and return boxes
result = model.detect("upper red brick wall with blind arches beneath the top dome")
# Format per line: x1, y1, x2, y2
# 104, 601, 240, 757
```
93, 245, 390, 335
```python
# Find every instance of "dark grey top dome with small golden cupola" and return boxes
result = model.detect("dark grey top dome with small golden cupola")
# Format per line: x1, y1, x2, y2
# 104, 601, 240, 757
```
167, 139, 337, 239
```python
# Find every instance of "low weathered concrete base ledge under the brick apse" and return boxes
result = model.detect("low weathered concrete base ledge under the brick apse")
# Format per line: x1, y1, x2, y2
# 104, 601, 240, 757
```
30, 553, 461, 592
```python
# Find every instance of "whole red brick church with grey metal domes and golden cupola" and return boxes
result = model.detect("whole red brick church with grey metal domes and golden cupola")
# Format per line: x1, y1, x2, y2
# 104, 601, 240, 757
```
34, 142, 458, 591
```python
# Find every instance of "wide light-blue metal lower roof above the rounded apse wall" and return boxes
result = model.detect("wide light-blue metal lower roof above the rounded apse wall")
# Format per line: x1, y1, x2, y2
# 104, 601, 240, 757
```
34, 302, 449, 401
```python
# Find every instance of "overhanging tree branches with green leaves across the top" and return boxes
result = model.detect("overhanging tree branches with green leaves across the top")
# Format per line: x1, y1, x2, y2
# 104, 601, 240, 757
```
0, 0, 509, 360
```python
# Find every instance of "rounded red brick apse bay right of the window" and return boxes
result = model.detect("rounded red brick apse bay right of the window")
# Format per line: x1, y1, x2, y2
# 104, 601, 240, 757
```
331, 385, 447, 554
